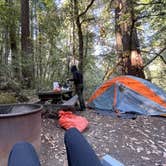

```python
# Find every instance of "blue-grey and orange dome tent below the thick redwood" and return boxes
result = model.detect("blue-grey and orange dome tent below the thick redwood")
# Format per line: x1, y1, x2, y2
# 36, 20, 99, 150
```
88, 76, 166, 115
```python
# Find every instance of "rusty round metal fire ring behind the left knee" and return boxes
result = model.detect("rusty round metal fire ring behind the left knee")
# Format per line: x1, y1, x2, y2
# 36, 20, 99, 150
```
0, 104, 42, 166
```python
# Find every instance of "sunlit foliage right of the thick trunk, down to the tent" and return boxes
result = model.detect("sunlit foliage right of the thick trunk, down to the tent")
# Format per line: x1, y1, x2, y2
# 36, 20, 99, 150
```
132, 0, 166, 89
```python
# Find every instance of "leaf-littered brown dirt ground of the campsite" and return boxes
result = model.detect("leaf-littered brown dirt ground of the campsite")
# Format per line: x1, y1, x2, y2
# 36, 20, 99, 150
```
40, 111, 166, 166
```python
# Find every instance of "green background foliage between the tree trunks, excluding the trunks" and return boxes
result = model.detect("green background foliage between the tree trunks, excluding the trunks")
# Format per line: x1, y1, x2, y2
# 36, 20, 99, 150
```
0, 0, 166, 94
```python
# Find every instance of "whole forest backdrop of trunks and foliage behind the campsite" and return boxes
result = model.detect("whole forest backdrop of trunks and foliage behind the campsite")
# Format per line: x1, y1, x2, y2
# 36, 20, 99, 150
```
0, 0, 166, 96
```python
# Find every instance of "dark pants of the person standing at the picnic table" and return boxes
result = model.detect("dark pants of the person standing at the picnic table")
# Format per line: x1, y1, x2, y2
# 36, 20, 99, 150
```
75, 84, 85, 111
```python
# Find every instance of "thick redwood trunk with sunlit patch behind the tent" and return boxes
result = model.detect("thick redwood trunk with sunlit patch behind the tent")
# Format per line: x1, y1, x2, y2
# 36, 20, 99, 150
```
115, 0, 145, 78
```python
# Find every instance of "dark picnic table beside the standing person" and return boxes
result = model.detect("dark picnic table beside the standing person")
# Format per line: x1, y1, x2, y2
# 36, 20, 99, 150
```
38, 90, 73, 104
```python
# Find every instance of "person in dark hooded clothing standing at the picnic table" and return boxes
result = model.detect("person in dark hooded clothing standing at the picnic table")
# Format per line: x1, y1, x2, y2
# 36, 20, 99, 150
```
69, 65, 86, 111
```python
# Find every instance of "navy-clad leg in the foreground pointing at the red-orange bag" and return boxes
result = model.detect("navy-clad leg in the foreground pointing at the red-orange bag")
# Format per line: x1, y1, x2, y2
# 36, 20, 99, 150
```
64, 128, 102, 166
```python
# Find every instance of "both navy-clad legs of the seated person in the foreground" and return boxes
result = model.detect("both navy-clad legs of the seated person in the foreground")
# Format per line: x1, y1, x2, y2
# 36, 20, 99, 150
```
8, 128, 102, 166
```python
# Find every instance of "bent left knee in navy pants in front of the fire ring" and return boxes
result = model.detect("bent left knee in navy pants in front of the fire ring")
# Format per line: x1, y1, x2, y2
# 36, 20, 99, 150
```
8, 142, 40, 166
